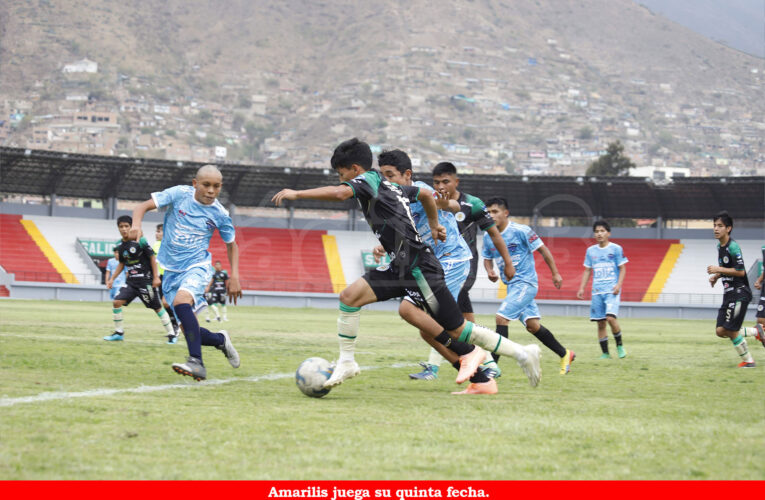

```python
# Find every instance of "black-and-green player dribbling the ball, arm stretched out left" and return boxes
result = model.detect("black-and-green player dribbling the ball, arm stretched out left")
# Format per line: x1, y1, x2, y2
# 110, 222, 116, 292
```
272, 138, 540, 387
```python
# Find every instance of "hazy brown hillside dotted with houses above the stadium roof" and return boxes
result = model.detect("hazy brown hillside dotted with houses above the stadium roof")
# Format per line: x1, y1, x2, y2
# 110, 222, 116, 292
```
0, 0, 765, 175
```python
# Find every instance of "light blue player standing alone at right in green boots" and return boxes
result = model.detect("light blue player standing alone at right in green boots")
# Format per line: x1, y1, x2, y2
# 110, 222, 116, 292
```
576, 220, 629, 359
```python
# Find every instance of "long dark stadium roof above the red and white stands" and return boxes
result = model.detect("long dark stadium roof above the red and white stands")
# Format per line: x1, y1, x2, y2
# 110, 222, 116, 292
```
0, 148, 765, 220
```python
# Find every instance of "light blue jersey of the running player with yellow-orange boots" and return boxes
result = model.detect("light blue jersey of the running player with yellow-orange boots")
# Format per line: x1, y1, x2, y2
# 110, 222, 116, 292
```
481, 221, 544, 287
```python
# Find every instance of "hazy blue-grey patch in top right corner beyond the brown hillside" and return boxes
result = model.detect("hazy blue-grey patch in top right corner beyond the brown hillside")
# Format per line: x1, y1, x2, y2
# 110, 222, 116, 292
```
634, 0, 765, 58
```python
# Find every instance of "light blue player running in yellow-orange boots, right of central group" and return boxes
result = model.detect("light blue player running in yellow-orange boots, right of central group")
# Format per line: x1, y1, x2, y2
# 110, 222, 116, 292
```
481, 198, 576, 375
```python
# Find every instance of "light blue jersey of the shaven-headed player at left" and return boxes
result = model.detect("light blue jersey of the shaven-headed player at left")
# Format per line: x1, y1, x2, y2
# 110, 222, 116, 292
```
151, 186, 236, 272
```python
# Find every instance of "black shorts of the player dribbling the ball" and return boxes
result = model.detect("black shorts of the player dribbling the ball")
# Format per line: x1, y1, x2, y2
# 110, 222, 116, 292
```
364, 252, 464, 330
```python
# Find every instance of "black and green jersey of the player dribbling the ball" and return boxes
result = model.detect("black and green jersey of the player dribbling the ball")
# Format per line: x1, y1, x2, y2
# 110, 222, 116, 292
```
343, 170, 428, 268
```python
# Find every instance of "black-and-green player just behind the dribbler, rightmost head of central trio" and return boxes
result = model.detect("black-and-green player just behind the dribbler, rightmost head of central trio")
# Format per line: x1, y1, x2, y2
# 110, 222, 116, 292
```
409, 162, 512, 380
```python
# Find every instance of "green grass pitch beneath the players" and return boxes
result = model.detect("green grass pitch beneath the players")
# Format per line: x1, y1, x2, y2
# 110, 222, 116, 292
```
0, 300, 765, 480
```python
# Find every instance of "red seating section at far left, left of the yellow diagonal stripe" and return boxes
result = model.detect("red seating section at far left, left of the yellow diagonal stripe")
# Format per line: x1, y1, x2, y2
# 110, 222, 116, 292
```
0, 214, 66, 283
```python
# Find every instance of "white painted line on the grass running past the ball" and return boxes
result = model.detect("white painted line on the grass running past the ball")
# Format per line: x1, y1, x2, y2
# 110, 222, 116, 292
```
0, 363, 414, 407
